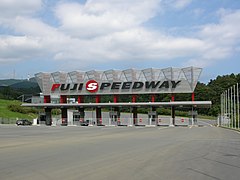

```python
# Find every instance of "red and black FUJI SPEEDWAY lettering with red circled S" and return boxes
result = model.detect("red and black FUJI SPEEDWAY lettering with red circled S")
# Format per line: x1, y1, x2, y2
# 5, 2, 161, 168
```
51, 80, 181, 94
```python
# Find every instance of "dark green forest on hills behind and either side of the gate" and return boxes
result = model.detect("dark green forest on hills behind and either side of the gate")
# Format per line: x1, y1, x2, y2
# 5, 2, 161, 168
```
0, 74, 240, 116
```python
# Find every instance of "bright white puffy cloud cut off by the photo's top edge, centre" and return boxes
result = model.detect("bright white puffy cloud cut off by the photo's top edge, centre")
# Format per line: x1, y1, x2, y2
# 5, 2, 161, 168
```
55, 0, 160, 38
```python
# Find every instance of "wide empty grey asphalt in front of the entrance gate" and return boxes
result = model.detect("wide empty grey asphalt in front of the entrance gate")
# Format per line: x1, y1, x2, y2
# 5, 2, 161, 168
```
0, 125, 240, 180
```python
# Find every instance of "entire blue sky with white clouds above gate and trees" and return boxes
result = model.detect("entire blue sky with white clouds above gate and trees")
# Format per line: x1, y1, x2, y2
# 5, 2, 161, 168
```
0, 0, 240, 83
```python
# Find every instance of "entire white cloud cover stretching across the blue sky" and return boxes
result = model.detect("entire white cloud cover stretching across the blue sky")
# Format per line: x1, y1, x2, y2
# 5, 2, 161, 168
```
0, 0, 240, 73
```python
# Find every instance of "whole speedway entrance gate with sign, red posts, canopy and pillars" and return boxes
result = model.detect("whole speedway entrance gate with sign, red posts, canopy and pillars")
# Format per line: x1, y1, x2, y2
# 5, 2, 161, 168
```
23, 67, 211, 126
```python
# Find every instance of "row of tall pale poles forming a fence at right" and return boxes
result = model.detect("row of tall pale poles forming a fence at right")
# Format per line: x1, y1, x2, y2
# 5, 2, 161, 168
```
218, 83, 240, 130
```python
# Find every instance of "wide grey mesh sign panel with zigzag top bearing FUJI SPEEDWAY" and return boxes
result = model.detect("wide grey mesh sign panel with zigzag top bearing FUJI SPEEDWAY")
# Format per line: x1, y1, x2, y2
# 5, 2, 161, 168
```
35, 67, 202, 95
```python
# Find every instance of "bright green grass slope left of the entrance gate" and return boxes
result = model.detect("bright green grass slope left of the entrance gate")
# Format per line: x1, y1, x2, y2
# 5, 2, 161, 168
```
0, 99, 36, 120
